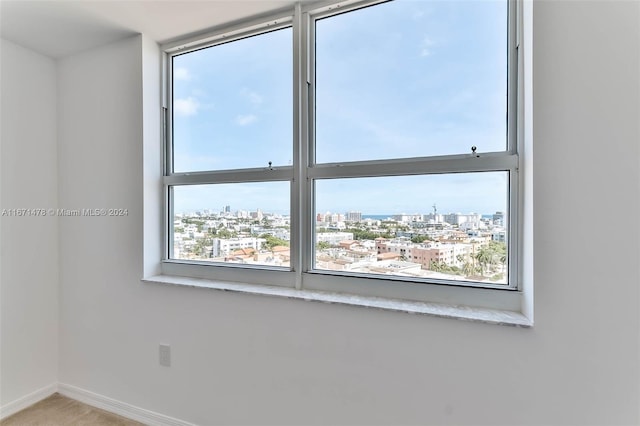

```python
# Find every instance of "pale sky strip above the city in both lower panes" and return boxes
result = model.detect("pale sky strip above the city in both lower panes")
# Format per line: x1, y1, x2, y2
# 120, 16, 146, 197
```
174, 172, 509, 214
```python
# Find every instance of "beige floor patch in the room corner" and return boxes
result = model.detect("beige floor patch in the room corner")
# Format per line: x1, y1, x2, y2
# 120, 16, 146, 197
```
0, 393, 142, 426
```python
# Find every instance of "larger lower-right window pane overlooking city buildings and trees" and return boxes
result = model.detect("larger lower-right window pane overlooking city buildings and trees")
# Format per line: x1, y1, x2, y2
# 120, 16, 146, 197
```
314, 172, 509, 284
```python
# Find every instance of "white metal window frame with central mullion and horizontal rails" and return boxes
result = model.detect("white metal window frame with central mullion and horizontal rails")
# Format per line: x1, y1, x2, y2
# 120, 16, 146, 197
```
156, 0, 522, 311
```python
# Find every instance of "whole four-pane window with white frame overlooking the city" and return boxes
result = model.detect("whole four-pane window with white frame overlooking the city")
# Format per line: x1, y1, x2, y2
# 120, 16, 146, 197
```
163, 0, 519, 308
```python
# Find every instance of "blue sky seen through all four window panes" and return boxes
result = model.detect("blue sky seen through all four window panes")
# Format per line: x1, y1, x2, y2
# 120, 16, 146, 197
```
173, 0, 507, 214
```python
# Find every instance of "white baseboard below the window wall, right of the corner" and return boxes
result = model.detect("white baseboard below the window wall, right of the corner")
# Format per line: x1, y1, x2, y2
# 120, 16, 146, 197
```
57, 383, 195, 426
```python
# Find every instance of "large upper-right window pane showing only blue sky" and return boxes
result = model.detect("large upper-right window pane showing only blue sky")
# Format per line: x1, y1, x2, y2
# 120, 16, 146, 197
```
315, 0, 508, 163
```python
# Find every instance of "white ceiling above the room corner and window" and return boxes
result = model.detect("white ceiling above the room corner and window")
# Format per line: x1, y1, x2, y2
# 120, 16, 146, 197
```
0, 0, 302, 58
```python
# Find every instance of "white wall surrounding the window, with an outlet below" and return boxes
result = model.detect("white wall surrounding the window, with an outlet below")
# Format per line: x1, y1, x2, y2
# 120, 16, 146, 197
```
51, 1, 640, 425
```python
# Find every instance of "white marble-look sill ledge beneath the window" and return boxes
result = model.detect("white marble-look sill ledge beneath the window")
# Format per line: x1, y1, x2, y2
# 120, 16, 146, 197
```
142, 275, 533, 328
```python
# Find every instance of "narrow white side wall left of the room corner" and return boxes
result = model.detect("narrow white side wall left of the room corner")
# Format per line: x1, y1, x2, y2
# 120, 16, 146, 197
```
0, 40, 58, 407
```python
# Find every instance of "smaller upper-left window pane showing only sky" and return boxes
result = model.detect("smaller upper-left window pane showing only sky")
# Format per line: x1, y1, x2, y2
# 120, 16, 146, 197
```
172, 28, 293, 172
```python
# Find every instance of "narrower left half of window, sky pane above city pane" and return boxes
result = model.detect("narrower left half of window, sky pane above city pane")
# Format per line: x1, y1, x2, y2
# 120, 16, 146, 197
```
166, 25, 294, 286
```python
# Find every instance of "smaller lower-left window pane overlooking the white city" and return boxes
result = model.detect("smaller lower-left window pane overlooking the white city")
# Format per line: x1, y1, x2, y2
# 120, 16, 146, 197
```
171, 182, 290, 268
